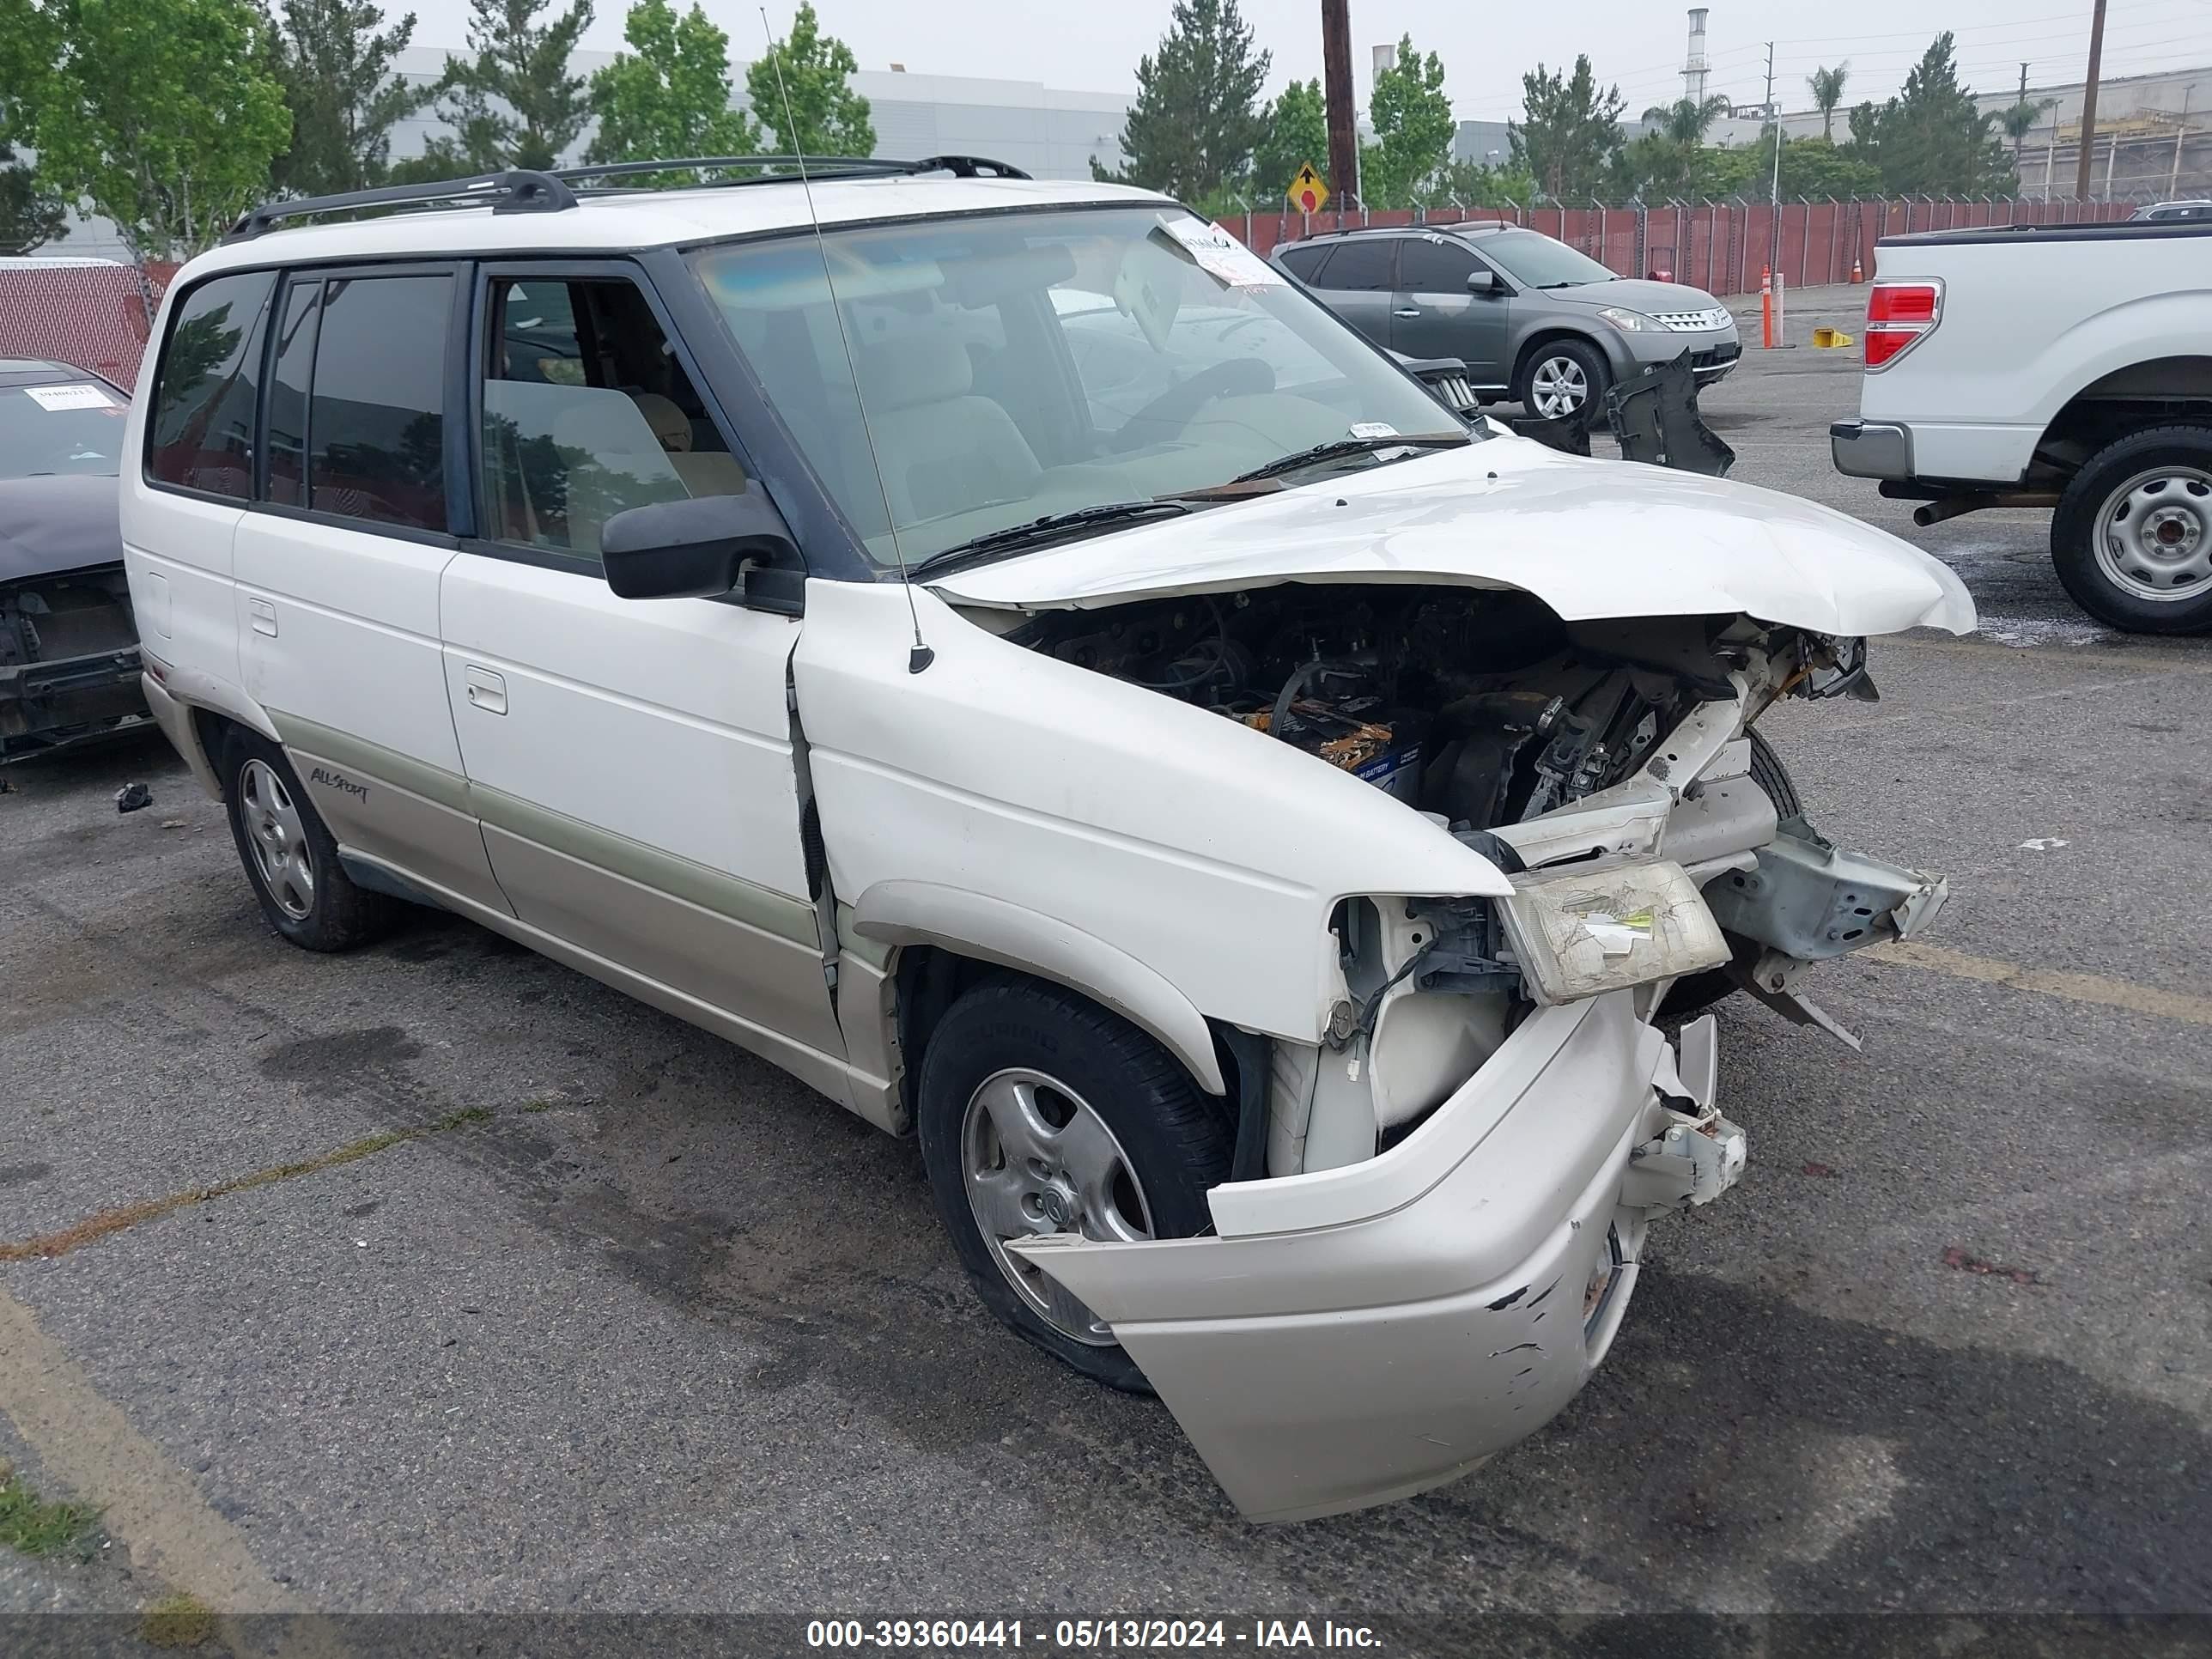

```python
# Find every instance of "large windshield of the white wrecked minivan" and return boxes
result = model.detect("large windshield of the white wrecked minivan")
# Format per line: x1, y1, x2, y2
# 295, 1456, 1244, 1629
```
692, 206, 1464, 566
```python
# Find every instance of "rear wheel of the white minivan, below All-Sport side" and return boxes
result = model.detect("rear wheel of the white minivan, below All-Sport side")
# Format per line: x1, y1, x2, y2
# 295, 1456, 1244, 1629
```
219, 728, 398, 951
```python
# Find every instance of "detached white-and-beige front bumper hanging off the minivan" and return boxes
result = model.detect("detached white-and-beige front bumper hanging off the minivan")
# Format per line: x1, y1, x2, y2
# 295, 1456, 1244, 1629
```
1013, 991, 1743, 1520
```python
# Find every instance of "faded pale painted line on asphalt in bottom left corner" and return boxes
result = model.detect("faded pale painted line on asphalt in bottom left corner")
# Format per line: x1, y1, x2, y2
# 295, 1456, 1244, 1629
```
0, 1287, 338, 1659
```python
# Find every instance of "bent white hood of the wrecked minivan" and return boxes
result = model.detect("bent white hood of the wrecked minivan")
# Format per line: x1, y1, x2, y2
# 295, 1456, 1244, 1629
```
929, 438, 1975, 635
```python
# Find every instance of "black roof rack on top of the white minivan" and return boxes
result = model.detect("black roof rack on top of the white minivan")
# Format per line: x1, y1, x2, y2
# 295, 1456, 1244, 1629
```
223, 155, 1029, 241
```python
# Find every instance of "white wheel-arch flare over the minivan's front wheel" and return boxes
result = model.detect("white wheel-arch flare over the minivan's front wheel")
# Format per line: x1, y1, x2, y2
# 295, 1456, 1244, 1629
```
852, 880, 1228, 1095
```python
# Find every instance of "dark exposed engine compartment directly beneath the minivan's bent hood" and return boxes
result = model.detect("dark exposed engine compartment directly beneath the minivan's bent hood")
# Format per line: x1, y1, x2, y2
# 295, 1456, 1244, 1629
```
1013, 586, 1871, 832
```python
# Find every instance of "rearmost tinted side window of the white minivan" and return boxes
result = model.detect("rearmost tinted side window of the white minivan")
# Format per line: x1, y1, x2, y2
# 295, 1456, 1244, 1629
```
146, 270, 276, 502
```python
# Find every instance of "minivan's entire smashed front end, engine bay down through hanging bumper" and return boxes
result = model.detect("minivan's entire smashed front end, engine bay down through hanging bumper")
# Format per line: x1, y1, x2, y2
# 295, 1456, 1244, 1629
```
998, 584, 1944, 1520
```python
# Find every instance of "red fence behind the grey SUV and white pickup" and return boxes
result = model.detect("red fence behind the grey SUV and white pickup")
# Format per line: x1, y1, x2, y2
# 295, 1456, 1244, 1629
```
1218, 197, 2135, 295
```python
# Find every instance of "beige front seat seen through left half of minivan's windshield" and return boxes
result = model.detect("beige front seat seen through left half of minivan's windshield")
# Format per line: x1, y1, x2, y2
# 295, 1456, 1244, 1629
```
856, 330, 1044, 525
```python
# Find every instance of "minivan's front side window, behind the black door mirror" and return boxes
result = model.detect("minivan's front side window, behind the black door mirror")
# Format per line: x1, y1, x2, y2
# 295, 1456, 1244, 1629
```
477, 276, 745, 560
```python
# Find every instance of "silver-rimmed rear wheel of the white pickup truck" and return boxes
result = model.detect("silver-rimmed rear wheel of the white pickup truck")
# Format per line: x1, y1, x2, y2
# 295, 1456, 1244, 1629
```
2051, 427, 2212, 633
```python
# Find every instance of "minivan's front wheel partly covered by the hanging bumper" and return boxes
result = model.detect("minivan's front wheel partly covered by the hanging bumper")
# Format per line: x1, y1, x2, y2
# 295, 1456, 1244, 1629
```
915, 978, 1230, 1391
